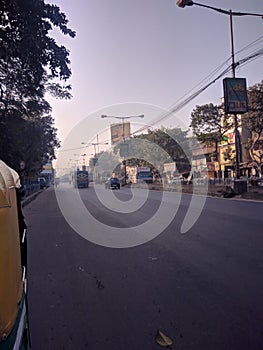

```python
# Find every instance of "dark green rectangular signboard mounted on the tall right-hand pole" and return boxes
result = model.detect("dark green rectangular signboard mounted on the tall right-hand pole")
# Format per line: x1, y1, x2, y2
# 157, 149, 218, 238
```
223, 78, 248, 114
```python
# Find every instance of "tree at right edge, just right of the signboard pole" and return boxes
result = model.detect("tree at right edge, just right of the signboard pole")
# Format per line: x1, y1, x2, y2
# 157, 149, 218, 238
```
243, 80, 263, 175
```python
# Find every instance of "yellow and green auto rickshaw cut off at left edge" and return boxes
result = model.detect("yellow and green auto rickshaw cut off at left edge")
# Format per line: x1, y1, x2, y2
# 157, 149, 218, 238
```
0, 160, 30, 350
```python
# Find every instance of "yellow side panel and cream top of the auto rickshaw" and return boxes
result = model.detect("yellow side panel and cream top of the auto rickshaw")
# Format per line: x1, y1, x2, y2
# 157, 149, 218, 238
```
0, 161, 23, 341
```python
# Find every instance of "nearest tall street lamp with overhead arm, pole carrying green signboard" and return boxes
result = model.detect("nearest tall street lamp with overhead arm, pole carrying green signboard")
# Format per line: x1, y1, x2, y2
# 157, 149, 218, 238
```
176, 0, 263, 179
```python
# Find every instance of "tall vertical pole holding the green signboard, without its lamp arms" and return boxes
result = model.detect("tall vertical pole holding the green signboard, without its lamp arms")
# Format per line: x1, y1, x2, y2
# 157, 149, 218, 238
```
229, 10, 240, 179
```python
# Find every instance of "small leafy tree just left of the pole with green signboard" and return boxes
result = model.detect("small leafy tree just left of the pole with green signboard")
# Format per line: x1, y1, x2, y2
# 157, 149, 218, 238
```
190, 103, 233, 159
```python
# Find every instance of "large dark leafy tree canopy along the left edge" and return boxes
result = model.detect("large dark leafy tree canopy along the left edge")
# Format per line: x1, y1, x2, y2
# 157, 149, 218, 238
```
0, 0, 75, 175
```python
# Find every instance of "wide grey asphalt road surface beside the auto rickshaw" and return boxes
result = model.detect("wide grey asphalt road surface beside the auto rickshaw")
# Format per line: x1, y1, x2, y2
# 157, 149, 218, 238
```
24, 187, 263, 350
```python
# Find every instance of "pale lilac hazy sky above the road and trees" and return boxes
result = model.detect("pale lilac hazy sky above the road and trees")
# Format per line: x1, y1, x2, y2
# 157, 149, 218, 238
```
48, 0, 263, 168
